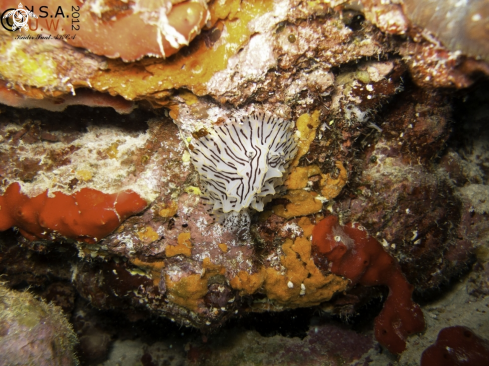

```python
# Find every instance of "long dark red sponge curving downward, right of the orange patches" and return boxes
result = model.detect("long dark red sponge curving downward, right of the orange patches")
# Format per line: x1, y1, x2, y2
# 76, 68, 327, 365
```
312, 216, 425, 353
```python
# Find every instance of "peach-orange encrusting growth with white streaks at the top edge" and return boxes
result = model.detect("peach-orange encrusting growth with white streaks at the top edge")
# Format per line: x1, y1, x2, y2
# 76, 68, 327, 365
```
10, 0, 210, 61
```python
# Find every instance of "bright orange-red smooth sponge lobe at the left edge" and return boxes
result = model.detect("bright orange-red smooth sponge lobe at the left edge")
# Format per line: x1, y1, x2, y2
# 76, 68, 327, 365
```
0, 183, 147, 243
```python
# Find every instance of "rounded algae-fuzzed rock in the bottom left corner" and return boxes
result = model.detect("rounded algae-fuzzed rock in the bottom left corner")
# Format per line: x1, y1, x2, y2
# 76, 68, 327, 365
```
0, 284, 78, 366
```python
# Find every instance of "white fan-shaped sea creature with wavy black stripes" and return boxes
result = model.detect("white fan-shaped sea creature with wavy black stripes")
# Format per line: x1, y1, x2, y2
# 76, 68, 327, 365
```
189, 113, 297, 213
